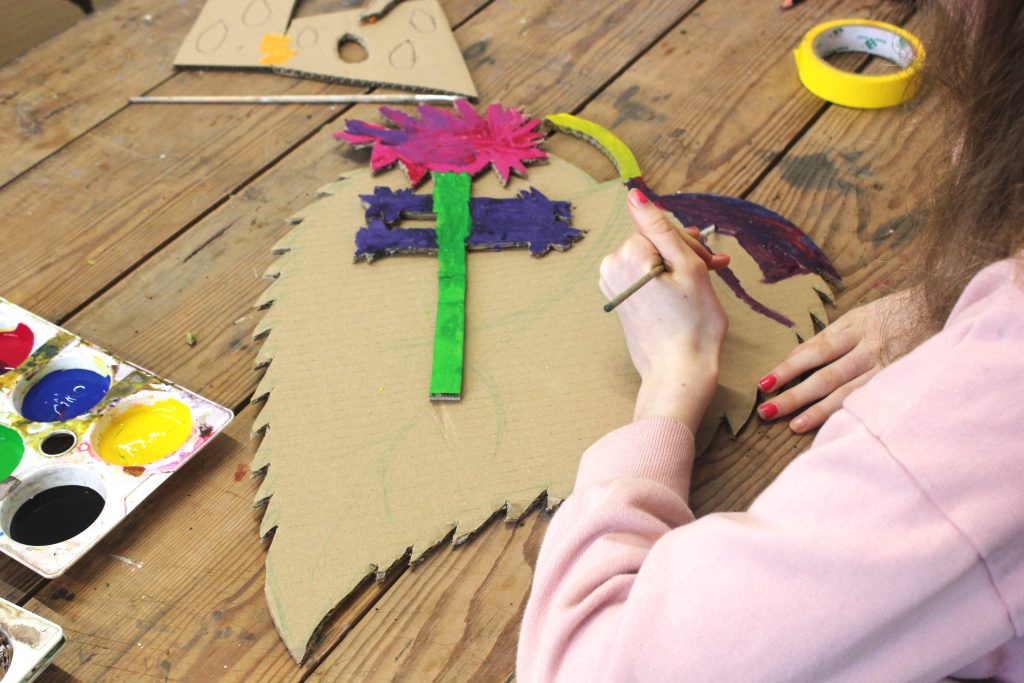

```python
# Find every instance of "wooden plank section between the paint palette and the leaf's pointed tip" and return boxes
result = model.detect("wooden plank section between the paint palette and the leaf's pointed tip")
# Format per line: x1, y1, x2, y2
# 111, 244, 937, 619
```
20, 409, 296, 681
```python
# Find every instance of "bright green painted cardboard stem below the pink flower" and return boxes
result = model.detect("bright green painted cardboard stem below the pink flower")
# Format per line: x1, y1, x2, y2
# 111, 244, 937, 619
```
430, 173, 472, 400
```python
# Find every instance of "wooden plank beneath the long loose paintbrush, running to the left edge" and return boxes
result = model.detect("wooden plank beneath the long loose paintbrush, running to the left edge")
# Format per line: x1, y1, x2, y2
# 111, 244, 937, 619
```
0, 0, 485, 319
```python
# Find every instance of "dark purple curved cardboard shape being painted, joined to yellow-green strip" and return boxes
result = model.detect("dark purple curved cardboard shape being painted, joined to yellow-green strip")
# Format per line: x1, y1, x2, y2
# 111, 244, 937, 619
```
626, 177, 842, 328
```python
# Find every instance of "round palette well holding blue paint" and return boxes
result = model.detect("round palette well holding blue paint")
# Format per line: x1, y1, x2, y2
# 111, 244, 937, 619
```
14, 356, 111, 422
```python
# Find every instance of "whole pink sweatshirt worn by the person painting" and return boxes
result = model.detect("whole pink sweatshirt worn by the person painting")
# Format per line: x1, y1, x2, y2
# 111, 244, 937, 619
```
517, 261, 1024, 683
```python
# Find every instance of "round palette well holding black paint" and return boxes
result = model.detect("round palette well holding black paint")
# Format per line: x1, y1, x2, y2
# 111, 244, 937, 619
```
0, 467, 106, 546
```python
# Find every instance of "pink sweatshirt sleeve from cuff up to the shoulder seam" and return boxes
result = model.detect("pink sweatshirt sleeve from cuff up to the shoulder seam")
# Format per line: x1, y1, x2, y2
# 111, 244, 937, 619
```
518, 405, 1013, 683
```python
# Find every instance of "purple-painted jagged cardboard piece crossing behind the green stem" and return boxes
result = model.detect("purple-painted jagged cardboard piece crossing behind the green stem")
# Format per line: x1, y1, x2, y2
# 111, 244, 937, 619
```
355, 187, 583, 261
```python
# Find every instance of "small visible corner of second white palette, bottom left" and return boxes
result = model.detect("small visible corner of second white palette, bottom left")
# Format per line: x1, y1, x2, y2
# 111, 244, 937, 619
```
0, 598, 65, 683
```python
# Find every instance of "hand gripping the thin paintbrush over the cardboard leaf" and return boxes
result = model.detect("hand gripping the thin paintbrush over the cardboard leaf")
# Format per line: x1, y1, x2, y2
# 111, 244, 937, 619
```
600, 189, 728, 431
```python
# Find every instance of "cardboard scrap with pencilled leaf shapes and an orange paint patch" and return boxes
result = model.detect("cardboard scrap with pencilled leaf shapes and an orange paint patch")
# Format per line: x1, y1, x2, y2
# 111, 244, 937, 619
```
174, 0, 476, 98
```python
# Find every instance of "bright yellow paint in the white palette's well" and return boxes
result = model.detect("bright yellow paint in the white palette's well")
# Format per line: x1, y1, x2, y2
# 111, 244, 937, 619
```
97, 398, 191, 467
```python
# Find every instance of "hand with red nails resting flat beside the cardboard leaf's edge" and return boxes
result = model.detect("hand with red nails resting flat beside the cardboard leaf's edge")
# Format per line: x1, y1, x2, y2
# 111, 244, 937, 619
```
758, 292, 909, 433
